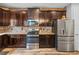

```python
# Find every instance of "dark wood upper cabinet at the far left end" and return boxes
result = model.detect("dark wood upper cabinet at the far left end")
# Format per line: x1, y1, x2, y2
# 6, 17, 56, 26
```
0, 9, 10, 26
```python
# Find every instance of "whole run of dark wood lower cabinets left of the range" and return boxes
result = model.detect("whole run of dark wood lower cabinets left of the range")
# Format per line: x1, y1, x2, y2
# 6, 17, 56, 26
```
0, 35, 26, 49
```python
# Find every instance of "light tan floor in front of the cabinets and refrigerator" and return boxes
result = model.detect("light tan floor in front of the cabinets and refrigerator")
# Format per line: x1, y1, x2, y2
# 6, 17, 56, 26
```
3, 48, 79, 55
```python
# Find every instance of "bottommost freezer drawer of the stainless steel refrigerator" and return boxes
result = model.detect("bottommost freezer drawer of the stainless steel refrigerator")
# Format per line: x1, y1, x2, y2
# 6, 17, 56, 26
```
57, 41, 74, 51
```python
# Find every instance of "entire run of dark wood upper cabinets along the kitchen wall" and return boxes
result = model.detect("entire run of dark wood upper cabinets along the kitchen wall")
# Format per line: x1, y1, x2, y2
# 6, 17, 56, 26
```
0, 8, 66, 26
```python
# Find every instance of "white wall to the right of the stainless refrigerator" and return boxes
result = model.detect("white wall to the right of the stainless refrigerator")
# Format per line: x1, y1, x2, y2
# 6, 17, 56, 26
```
66, 3, 79, 51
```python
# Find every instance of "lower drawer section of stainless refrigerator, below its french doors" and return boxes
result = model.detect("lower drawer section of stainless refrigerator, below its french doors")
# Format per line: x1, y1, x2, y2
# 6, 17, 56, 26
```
57, 37, 74, 51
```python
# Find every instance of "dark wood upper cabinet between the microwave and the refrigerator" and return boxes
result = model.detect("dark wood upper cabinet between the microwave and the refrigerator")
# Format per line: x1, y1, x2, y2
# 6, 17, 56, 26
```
39, 11, 56, 26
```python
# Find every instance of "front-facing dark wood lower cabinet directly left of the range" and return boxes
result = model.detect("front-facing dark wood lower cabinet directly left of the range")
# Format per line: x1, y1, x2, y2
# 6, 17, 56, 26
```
8, 35, 26, 48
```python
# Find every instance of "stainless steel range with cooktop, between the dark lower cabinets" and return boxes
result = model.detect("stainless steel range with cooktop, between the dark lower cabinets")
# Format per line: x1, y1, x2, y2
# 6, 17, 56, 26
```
26, 28, 39, 49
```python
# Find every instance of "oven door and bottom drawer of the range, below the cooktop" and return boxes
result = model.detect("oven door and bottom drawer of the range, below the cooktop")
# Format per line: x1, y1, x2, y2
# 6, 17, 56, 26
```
26, 35, 39, 49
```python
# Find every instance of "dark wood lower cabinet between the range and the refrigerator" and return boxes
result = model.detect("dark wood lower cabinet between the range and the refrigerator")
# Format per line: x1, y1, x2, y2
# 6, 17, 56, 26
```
39, 35, 55, 48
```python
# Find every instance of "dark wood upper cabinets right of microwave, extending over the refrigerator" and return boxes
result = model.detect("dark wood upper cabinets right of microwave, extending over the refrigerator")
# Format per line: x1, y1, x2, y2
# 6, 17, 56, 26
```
39, 11, 66, 26
